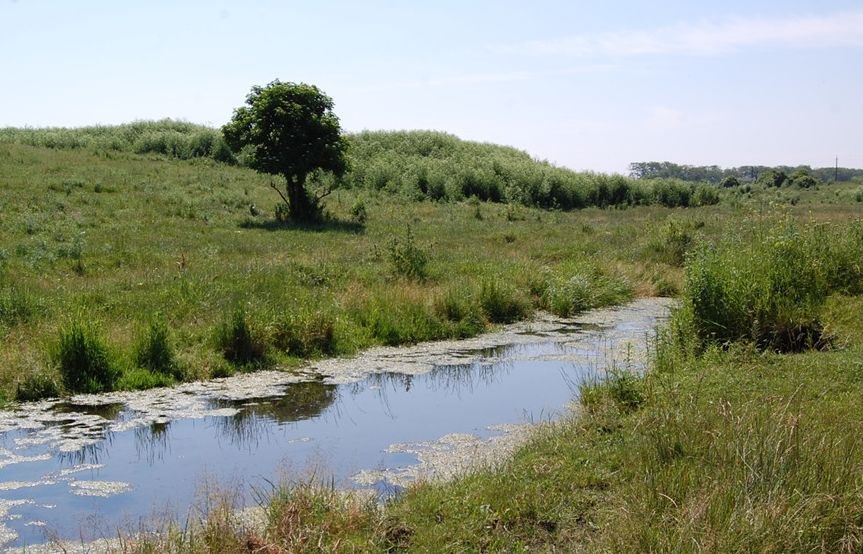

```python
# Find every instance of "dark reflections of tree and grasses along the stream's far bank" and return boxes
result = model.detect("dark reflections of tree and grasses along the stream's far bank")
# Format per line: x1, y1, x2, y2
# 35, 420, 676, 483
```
38, 343, 566, 466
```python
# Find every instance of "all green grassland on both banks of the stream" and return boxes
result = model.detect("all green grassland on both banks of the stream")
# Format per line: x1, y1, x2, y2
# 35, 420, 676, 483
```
0, 123, 863, 552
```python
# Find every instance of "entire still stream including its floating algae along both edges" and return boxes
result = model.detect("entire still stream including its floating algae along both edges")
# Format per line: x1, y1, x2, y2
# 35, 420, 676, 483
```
0, 298, 671, 549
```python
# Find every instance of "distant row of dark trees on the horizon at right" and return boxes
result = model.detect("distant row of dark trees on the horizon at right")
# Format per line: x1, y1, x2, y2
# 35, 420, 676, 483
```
629, 162, 863, 186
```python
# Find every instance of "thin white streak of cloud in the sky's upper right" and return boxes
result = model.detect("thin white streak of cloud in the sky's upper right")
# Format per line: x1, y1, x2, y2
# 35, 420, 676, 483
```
502, 11, 863, 56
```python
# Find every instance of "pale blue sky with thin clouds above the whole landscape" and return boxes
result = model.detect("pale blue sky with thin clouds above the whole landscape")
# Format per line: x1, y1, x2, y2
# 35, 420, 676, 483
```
0, 0, 863, 173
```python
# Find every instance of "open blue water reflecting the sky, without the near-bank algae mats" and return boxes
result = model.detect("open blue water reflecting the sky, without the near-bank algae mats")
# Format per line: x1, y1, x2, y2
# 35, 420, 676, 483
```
0, 296, 676, 548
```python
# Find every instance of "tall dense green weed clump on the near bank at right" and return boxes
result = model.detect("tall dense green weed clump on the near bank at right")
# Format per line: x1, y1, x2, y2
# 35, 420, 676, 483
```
680, 222, 863, 351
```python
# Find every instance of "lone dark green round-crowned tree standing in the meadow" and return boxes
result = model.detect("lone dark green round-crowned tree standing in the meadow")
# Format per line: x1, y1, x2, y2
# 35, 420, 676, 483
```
222, 80, 347, 221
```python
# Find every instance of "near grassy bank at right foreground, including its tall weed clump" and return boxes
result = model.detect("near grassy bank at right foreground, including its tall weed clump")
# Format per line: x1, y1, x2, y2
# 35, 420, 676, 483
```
120, 213, 863, 552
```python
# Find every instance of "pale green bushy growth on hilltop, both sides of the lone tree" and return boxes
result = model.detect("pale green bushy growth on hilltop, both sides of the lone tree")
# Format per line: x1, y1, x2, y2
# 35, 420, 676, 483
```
0, 120, 719, 210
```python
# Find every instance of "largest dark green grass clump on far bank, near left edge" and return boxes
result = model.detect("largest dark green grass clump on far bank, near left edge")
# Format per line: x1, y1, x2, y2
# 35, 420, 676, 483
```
57, 321, 120, 393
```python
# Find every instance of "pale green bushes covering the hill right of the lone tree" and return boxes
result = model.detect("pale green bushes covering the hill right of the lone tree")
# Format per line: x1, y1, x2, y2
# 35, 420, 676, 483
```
345, 131, 719, 210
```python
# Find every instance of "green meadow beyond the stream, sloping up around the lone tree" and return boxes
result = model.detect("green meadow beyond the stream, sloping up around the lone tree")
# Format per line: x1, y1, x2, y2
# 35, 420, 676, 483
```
0, 124, 720, 400
